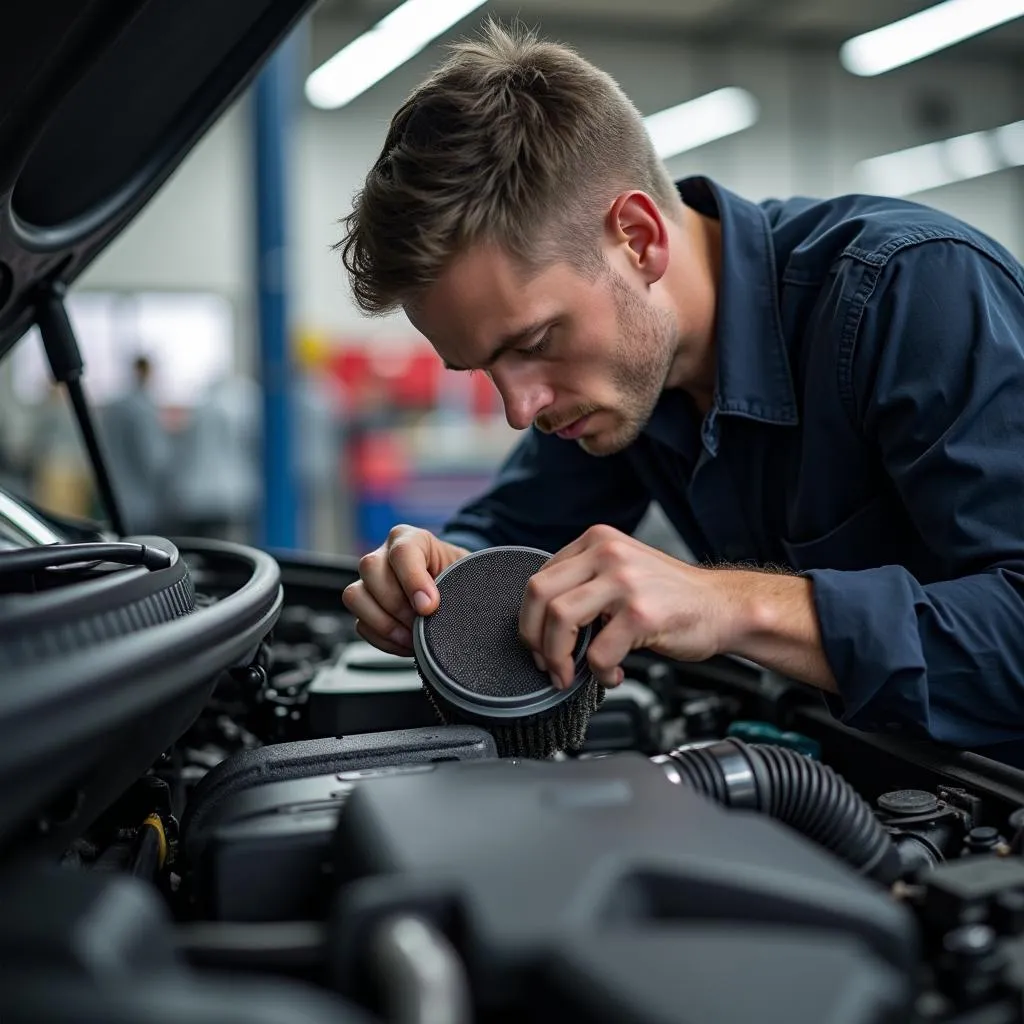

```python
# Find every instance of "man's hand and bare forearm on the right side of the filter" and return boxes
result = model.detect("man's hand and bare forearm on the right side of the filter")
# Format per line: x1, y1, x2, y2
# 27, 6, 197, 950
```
519, 526, 835, 690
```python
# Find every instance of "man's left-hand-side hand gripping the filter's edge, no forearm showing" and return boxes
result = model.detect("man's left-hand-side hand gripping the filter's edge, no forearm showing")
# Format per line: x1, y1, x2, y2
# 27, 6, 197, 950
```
341, 525, 469, 656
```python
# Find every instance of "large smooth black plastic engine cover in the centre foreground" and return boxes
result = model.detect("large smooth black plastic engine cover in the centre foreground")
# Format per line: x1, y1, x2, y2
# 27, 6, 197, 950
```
335, 754, 918, 1024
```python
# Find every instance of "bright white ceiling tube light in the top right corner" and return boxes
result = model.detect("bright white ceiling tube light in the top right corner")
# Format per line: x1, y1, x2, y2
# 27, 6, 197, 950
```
839, 0, 1024, 76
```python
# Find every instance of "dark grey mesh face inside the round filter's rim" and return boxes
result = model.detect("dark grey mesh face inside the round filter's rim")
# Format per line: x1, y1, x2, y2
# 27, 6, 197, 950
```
424, 549, 585, 697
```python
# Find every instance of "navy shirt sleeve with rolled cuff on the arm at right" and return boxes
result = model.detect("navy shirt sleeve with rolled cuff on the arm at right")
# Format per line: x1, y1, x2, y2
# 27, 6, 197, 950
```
805, 240, 1024, 748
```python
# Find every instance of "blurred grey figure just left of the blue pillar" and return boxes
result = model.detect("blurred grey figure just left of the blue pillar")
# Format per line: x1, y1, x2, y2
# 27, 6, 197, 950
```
168, 373, 261, 542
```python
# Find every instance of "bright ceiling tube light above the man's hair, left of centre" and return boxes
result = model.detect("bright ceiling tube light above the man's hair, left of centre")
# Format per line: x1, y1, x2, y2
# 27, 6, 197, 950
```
305, 0, 486, 110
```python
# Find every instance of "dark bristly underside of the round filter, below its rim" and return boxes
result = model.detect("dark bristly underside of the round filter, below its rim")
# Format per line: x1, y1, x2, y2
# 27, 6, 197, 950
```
420, 674, 604, 760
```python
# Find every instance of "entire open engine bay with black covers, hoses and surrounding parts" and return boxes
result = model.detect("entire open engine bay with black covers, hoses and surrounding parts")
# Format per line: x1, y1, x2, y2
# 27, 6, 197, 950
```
6, 542, 1024, 1024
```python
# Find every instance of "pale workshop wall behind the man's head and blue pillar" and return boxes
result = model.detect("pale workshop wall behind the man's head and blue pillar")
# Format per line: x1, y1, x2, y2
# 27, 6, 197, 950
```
75, 16, 1024, 344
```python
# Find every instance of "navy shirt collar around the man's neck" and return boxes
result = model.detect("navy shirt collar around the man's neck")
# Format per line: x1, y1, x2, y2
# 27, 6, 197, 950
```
676, 177, 800, 436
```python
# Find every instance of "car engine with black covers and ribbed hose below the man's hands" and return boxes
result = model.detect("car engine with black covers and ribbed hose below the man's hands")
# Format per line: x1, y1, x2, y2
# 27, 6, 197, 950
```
157, 589, 1024, 1022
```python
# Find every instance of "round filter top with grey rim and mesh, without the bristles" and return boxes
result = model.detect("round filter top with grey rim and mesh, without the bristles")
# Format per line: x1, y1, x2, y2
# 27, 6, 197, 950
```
413, 547, 593, 719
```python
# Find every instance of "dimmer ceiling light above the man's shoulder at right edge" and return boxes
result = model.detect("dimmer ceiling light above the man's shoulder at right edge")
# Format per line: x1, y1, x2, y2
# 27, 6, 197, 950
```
854, 121, 1024, 196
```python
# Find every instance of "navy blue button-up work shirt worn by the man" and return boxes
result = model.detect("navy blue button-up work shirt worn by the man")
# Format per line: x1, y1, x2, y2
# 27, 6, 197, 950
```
442, 178, 1024, 763
